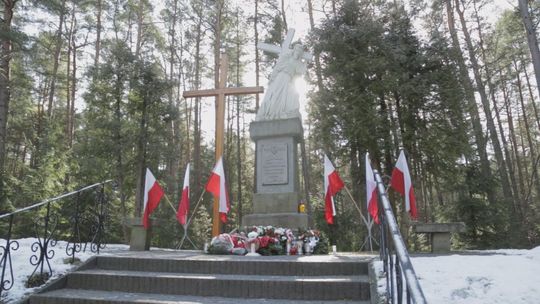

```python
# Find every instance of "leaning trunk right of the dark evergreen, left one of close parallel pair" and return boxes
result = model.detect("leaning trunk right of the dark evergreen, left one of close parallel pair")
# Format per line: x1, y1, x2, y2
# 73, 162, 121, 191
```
446, 0, 496, 202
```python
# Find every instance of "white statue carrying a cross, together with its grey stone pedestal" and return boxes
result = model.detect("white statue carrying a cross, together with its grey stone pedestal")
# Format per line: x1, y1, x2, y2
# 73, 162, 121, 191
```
242, 30, 311, 229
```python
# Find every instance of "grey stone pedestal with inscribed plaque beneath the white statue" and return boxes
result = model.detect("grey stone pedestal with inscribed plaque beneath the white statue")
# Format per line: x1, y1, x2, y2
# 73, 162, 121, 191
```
242, 118, 308, 229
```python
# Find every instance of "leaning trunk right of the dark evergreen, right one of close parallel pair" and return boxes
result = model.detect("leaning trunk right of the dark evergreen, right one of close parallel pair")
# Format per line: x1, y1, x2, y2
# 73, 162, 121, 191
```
455, 0, 513, 202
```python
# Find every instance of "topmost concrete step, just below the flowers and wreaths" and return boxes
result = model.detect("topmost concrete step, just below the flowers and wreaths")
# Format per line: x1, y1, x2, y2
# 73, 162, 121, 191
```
95, 256, 369, 276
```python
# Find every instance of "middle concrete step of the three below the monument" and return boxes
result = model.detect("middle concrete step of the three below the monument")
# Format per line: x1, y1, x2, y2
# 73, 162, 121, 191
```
62, 269, 370, 300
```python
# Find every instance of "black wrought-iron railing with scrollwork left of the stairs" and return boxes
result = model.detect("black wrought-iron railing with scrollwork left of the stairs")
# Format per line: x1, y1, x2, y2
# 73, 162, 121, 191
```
0, 180, 112, 298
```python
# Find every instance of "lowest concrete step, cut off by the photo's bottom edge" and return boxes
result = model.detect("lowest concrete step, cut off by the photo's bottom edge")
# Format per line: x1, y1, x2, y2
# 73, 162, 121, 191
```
30, 289, 369, 304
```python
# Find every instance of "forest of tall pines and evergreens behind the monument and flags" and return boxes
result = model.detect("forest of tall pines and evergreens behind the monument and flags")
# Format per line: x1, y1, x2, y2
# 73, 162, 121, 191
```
0, 0, 540, 250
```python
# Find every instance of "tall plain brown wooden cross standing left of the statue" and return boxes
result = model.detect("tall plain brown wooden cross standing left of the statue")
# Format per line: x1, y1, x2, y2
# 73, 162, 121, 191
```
183, 54, 264, 236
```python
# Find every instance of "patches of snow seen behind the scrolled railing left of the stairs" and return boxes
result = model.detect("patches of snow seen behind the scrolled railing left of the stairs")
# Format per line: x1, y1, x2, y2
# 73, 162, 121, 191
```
0, 238, 129, 303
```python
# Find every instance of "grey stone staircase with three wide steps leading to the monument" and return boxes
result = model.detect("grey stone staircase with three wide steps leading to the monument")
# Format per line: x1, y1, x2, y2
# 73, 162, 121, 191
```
26, 251, 371, 304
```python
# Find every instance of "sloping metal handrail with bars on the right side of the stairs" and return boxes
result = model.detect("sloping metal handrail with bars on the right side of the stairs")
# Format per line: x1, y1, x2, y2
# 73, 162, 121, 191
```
373, 170, 427, 304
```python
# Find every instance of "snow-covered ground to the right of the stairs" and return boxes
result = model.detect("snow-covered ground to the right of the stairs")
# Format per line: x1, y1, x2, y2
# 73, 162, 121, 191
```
376, 247, 540, 304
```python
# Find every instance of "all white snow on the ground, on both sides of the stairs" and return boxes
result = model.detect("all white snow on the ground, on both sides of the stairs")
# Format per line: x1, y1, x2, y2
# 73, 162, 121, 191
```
4, 238, 540, 304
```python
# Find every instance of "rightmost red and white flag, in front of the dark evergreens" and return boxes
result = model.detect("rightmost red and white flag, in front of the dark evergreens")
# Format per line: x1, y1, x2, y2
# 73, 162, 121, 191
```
390, 150, 417, 219
